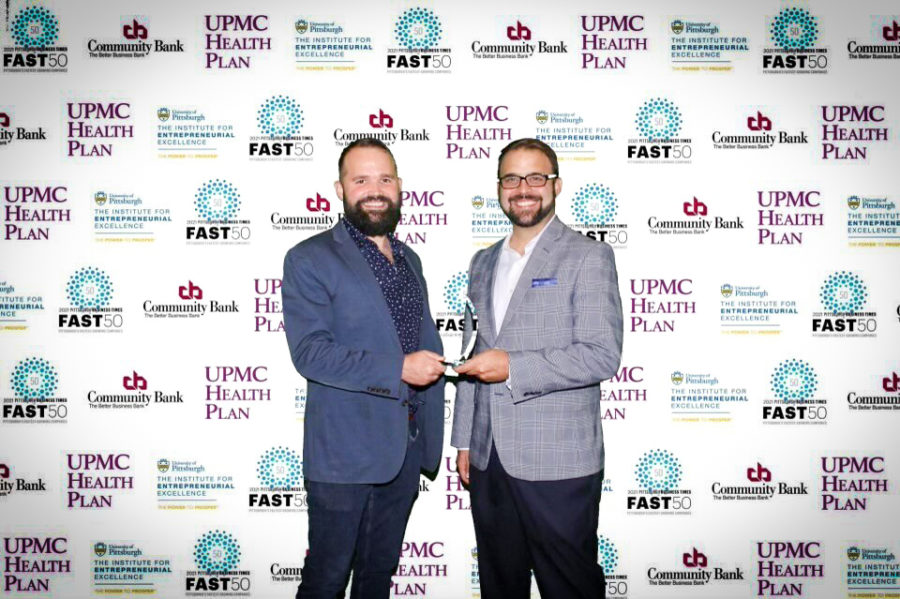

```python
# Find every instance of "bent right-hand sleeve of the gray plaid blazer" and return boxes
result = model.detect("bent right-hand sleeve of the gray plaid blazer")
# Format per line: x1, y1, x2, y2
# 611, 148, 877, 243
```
509, 243, 623, 403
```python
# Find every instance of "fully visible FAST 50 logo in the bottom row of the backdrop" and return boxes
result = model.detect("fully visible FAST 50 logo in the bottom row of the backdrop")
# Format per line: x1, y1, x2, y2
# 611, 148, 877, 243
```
184, 530, 252, 597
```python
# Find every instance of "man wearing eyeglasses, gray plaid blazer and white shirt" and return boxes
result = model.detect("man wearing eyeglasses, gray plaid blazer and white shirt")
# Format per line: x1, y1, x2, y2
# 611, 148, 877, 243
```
451, 139, 622, 599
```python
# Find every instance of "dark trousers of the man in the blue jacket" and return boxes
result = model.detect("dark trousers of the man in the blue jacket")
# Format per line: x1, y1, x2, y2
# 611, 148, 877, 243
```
297, 435, 424, 599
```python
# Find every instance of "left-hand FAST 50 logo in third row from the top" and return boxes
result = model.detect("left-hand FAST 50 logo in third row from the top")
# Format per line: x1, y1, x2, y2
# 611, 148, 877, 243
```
185, 179, 251, 245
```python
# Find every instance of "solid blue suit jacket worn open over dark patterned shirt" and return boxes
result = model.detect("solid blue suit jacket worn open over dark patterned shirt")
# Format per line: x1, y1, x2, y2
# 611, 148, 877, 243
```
281, 221, 444, 484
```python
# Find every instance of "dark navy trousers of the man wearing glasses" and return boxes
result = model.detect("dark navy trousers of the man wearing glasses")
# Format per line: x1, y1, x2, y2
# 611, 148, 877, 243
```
469, 445, 606, 599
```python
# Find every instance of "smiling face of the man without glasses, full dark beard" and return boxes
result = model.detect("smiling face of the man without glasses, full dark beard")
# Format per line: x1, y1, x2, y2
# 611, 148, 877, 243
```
334, 147, 401, 237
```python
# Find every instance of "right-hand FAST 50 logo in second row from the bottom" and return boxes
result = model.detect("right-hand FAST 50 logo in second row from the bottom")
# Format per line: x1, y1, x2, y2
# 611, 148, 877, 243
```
626, 449, 691, 516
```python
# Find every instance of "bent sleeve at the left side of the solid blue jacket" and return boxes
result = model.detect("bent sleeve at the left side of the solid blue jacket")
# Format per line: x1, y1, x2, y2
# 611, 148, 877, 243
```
281, 248, 407, 399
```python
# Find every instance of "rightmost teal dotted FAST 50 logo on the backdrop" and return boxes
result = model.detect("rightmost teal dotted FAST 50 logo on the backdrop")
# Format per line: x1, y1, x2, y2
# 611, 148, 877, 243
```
812, 270, 878, 337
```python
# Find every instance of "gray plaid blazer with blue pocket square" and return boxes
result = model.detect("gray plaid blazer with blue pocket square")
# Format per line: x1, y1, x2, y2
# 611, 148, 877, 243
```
451, 217, 622, 480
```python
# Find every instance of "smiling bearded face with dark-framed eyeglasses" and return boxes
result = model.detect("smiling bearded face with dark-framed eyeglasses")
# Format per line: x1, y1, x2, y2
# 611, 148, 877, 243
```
497, 149, 562, 228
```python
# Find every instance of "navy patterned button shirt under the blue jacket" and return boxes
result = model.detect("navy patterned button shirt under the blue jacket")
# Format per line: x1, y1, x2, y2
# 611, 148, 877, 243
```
342, 219, 425, 368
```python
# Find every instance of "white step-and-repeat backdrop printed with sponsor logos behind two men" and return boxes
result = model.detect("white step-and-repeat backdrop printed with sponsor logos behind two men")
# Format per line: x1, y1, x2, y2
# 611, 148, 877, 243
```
0, 0, 900, 599
